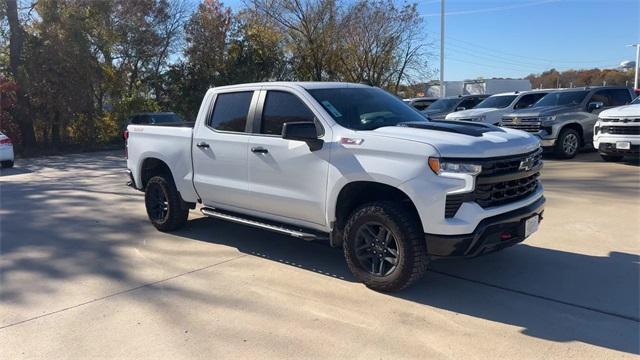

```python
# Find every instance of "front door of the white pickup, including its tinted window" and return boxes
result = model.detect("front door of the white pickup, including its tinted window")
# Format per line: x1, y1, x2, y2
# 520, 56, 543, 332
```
249, 87, 330, 225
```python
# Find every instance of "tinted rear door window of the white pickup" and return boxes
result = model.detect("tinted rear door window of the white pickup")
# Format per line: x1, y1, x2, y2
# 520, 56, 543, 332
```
208, 91, 253, 132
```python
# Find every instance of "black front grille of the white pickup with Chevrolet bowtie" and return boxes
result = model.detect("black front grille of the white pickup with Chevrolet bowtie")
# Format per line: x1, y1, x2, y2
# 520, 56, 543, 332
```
445, 149, 542, 218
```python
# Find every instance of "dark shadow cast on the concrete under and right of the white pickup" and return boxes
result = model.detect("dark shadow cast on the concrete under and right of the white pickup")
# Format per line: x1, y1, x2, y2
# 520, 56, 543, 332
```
175, 218, 640, 354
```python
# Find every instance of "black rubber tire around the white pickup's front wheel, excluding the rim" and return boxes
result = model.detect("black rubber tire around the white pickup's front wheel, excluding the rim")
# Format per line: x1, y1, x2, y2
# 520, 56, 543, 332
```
343, 201, 428, 292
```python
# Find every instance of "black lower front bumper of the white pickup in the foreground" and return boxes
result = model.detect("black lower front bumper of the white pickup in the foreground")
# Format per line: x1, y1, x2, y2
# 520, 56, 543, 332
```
425, 197, 545, 258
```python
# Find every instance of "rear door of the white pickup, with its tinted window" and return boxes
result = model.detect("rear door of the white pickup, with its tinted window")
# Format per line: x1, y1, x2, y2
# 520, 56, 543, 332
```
192, 90, 259, 210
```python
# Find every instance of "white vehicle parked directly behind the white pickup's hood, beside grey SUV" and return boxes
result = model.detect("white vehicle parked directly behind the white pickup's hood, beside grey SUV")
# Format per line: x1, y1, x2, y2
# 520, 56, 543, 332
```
446, 90, 551, 125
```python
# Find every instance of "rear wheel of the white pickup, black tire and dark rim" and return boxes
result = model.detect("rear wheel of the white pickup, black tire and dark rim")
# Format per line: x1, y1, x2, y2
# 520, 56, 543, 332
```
144, 176, 189, 231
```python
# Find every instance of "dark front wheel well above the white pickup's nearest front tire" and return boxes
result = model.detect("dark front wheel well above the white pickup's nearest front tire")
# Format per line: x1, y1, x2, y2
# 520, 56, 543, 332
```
334, 181, 420, 231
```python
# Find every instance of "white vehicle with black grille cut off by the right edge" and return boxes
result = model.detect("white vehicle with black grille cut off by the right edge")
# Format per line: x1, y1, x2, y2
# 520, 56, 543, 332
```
593, 97, 640, 161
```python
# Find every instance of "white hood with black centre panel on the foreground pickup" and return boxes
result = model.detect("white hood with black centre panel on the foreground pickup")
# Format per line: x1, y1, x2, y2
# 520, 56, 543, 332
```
372, 121, 540, 158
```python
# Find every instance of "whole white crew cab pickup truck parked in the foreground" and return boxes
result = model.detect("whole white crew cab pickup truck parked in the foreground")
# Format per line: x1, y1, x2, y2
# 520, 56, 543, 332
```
127, 82, 545, 291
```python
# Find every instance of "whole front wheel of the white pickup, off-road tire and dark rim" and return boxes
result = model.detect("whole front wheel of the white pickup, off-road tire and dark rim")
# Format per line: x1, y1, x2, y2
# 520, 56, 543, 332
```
344, 201, 428, 291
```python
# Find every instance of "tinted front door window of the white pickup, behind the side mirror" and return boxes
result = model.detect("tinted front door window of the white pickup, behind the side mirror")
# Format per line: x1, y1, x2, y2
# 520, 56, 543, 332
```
260, 91, 315, 135
